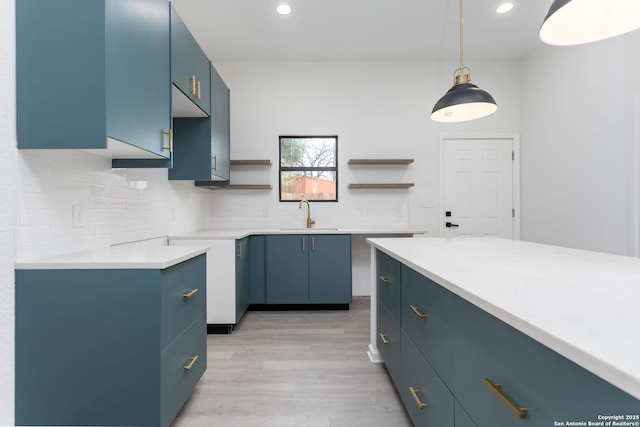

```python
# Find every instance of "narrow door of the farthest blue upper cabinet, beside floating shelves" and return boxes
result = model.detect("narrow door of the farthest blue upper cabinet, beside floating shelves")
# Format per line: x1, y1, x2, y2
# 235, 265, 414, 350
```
209, 66, 231, 181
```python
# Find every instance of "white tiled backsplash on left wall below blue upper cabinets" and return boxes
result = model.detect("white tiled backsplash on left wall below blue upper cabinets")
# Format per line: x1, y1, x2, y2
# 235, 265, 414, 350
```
17, 150, 210, 260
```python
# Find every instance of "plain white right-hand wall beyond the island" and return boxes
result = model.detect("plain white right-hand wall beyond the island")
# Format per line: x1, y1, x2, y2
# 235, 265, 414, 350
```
521, 37, 638, 254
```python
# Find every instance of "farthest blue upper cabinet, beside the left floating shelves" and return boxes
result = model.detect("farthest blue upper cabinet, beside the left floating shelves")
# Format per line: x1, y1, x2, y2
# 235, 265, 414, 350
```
169, 66, 229, 181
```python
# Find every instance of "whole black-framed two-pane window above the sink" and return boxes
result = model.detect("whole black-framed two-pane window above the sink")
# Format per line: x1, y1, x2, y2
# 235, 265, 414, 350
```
280, 135, 338, 202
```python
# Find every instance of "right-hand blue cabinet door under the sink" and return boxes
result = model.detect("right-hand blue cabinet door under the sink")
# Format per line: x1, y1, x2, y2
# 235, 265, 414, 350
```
308, 234, 352, 304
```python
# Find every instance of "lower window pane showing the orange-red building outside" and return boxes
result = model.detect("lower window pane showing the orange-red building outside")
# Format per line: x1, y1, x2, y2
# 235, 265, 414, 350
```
280, 171, 337, 200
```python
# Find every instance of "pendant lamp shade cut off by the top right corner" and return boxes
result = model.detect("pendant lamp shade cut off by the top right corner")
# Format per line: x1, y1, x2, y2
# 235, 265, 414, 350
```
539, 0, 640, 46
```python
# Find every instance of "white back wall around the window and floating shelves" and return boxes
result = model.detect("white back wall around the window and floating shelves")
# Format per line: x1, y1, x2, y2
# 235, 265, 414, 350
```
209, 62, 520, 295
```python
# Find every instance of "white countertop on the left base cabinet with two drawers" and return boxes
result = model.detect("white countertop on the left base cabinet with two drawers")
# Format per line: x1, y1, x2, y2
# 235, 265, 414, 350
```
15, 245, 209, 270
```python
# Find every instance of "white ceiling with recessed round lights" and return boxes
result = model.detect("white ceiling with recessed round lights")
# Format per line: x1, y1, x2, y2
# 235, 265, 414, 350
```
172, 0, 551, 61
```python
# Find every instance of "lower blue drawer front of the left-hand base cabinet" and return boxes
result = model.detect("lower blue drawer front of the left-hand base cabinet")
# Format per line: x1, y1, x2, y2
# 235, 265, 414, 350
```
160, 314, 207, 427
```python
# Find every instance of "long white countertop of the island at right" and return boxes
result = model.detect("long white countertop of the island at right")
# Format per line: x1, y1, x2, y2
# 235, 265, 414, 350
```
367, 238, 640, 399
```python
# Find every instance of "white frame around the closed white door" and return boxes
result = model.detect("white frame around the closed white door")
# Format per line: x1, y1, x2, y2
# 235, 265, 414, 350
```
438, 133, 522, 240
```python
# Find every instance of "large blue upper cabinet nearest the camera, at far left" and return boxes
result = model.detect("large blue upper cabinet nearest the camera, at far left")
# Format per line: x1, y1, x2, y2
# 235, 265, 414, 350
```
16, 0, 171, 163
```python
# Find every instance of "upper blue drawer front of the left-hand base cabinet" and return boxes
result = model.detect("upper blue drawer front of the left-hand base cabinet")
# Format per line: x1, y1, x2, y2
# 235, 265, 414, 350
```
161, 254, 207, 349
